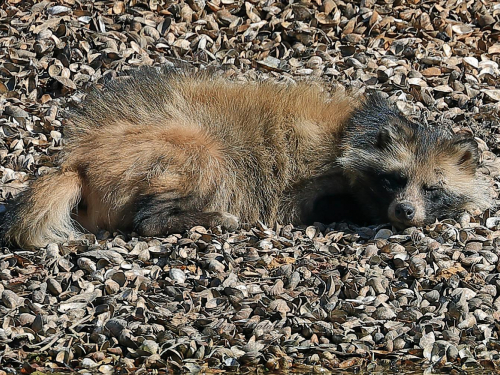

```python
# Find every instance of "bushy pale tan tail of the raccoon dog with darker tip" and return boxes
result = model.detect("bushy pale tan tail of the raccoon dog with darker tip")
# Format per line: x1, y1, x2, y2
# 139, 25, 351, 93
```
1, 171, 82, 249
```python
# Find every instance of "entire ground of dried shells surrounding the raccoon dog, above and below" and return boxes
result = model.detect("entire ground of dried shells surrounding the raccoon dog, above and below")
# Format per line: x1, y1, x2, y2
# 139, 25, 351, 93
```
0, 0, 500, 374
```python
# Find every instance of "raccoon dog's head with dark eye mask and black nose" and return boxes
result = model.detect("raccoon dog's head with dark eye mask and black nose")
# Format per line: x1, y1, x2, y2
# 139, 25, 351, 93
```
339, 95, 493, 229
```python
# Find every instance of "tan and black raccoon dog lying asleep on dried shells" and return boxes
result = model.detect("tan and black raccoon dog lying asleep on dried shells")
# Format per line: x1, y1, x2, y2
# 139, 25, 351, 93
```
3, 68, 492, 248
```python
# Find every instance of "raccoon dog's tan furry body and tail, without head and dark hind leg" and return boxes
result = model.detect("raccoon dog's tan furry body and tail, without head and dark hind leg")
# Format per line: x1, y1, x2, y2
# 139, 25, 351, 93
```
1, 71, 358, 247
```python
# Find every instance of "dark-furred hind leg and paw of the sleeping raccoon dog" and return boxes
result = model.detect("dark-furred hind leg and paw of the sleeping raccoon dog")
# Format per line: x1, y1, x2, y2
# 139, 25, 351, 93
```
134, 196, 238, 236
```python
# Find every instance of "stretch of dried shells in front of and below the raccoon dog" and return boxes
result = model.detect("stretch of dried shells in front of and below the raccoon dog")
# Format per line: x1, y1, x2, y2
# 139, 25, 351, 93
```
6, 220, 500, 373
